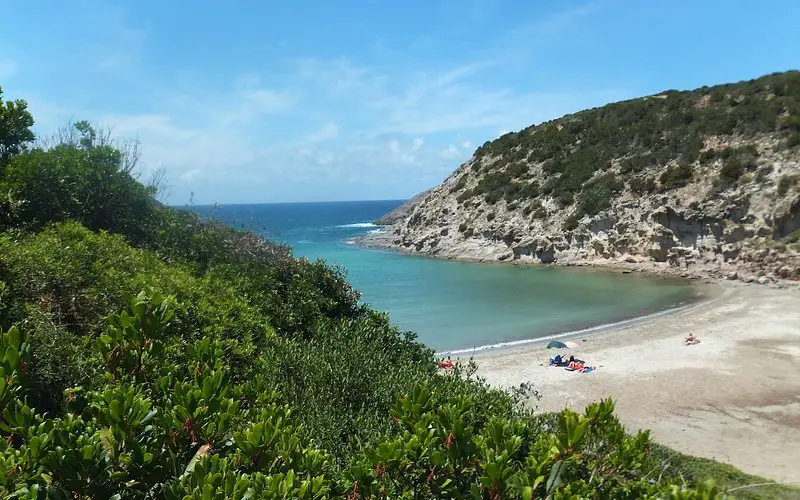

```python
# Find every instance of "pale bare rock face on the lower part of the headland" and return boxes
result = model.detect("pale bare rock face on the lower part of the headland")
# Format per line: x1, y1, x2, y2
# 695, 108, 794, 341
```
363, 135, 800, 283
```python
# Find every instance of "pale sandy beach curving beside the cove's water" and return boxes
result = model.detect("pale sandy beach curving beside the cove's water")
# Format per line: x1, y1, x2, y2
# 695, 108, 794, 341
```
468, 283, 800, 481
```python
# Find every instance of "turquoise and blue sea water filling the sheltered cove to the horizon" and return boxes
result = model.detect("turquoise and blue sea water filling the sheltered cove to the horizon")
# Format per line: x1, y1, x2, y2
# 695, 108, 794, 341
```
195, 201, 697, 351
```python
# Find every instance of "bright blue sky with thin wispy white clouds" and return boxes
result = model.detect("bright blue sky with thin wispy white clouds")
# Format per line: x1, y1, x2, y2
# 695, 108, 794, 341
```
0, 0, 800, 204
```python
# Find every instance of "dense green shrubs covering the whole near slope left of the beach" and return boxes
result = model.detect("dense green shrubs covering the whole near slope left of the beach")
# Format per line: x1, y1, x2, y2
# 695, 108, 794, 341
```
0, 85, 782, 499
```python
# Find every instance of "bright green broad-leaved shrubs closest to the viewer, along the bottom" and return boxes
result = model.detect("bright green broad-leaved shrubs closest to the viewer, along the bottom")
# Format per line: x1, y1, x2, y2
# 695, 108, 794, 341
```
0, 292, 716, 498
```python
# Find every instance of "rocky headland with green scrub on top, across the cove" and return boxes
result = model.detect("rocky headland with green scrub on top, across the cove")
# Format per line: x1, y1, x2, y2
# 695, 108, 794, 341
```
365, 71, 800, 282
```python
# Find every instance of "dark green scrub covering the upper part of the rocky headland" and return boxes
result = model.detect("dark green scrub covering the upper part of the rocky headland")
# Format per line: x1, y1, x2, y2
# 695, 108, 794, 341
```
453, 71, 800, 222
